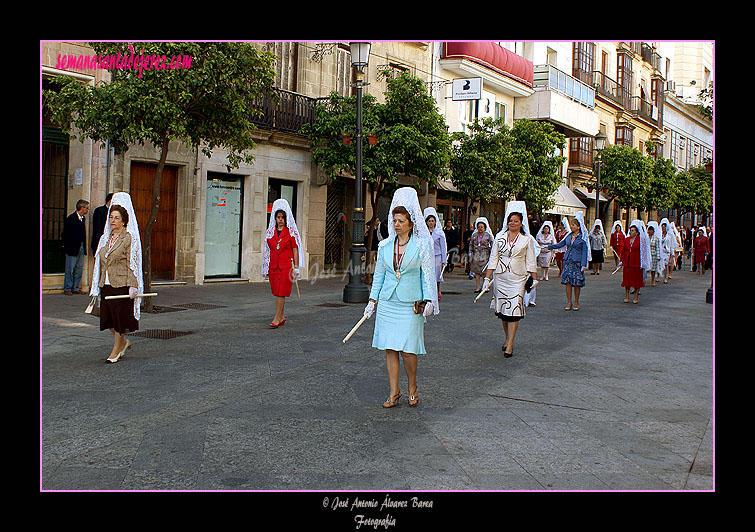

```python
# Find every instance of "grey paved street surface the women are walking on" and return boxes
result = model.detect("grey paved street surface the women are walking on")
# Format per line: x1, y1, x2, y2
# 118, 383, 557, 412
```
40, 262, 714, 492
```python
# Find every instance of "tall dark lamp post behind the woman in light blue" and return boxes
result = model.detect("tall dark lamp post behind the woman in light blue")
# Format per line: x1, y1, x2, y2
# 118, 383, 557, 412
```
343, 42, 370, 303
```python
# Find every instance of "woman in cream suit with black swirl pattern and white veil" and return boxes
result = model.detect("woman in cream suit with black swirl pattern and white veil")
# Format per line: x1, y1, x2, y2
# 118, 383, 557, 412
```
482, 201, 538, 358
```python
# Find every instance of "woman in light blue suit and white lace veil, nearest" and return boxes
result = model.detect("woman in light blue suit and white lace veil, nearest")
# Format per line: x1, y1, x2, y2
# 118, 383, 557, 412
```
364, 187, 438, 408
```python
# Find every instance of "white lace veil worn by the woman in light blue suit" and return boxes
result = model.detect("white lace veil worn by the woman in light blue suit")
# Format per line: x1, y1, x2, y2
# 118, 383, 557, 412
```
390, 187, 440, 314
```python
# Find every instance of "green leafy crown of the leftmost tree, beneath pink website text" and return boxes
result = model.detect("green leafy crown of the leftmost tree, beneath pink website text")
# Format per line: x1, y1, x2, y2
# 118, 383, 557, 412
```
44, 42, 275, 169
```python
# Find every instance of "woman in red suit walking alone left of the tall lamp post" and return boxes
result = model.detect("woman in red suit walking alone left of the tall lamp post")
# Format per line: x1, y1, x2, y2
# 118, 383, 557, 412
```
262, 199, 301, 329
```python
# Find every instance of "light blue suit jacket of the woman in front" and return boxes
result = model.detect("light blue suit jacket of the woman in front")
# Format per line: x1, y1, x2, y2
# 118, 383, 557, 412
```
370, 236, 435, 303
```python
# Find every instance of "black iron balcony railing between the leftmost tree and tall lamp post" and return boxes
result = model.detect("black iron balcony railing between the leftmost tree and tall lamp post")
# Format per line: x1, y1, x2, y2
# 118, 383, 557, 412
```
249, 88, 316, 133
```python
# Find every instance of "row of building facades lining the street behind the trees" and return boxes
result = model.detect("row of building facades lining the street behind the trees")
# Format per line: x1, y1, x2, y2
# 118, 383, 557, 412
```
40, 42, 713, 292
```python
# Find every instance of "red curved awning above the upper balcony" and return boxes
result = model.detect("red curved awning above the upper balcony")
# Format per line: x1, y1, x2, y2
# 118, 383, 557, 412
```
442, 41, 534, 87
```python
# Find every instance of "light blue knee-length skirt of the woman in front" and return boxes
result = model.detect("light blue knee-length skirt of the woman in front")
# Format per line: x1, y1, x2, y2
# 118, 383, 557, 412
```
372, 293, 426, 355
